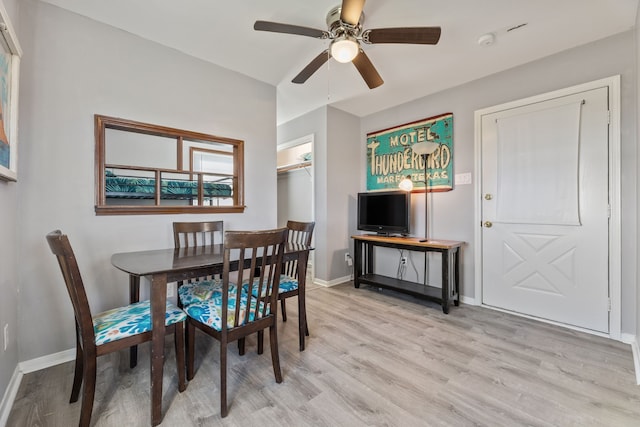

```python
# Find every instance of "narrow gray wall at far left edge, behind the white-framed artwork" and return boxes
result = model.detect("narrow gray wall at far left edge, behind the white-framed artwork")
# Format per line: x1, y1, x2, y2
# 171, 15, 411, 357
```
0, 0, 22, 409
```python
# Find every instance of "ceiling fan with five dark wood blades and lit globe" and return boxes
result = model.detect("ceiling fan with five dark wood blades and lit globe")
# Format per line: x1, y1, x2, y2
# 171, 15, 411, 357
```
253, 0, 441, 89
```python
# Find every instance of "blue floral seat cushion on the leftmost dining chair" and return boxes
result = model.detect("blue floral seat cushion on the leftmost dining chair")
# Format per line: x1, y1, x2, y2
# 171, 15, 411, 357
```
93, 300, 187, 345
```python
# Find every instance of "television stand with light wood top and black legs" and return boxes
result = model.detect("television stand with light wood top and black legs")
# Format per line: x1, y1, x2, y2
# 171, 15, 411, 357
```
351, 234, 464, 314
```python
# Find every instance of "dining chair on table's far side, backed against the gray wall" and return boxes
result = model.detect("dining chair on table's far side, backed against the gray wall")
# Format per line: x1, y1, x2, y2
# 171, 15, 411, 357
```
173, 221, 224, 308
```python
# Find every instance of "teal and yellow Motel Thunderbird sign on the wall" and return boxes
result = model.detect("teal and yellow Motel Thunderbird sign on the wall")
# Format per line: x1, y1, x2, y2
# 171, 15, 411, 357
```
367, 113, 453, 192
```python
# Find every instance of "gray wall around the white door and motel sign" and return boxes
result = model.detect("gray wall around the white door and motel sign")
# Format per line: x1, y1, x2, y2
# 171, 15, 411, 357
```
360, 31, 638, 334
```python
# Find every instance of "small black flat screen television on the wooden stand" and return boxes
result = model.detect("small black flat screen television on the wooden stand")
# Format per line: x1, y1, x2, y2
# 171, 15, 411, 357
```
358, 191, 411, 235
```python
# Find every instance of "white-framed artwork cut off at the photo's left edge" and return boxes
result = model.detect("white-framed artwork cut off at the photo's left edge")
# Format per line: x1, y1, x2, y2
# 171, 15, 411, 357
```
0, 3, 22, 181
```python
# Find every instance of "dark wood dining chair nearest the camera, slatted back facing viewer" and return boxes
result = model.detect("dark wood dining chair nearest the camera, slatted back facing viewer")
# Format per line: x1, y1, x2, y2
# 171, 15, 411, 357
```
185, 228, 287, 417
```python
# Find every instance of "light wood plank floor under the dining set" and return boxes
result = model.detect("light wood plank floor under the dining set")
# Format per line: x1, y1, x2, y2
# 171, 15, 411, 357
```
8, 284, 640, 427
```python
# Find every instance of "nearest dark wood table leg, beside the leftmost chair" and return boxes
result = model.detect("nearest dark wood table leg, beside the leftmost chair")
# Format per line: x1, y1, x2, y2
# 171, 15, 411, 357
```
151, 273, 167, 426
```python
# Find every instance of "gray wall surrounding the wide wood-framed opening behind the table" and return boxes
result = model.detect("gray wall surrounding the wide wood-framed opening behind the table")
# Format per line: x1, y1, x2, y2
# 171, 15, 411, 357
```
13, 0, 276, 360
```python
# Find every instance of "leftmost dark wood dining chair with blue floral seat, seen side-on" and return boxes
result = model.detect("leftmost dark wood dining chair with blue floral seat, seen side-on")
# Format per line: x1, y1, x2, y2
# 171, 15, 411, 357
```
47, 230, 186, 427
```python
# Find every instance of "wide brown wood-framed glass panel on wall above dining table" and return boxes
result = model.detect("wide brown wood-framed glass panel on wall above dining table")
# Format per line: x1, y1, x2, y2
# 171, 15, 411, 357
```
95, 115, 244, 215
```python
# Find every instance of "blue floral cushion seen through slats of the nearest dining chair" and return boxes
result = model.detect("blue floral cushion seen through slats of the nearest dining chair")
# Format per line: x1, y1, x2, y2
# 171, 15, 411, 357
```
184, 291, 270, 331
